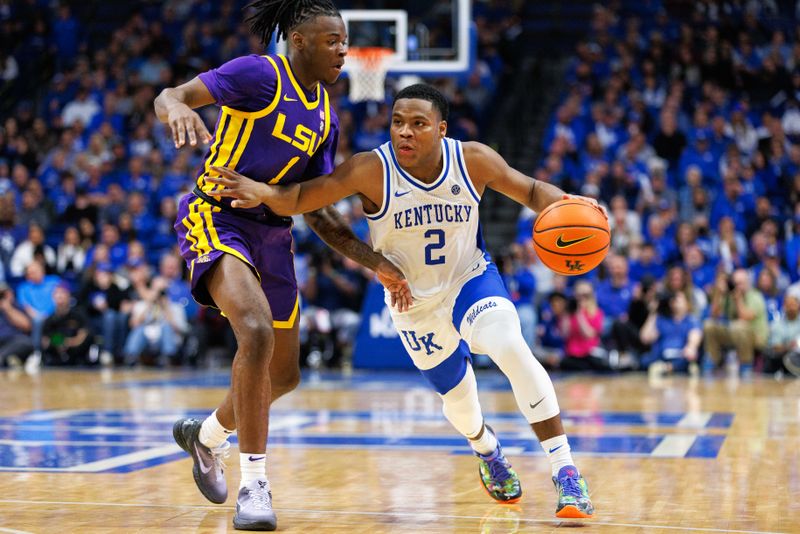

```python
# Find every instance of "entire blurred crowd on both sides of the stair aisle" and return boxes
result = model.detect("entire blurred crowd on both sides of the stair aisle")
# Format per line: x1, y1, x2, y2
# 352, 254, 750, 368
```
0, 0, 800, 374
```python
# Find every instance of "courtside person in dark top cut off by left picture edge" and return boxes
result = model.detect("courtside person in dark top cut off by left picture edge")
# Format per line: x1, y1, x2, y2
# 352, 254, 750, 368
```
0, 283, 34, 371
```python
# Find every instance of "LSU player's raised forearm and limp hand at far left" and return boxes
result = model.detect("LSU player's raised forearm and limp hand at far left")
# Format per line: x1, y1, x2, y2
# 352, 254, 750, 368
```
153, 78, 214, 148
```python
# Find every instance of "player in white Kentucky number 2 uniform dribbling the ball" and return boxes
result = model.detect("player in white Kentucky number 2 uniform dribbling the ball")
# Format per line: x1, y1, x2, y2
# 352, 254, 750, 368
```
207, 84, 601, 518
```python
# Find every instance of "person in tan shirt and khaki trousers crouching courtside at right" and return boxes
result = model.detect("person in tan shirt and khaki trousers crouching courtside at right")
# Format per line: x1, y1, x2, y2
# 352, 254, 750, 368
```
703, 269, 769, 376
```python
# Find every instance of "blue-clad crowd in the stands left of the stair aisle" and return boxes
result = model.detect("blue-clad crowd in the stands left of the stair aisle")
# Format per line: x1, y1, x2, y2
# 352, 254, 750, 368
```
0, 0, 510, 368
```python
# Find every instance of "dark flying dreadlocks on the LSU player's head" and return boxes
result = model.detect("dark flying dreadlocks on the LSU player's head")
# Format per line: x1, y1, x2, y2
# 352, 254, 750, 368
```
246, 0, 341, 44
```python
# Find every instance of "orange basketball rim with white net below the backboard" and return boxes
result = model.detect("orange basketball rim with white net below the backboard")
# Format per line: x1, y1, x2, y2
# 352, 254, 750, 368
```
347, 46, 395, 102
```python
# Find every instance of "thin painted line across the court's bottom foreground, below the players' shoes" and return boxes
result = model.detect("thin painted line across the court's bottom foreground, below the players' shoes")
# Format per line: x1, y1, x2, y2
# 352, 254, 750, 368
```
0, 499, 783, 534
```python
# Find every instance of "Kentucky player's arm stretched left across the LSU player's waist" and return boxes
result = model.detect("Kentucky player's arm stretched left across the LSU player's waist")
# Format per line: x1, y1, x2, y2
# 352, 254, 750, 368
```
206, 152, 383, 215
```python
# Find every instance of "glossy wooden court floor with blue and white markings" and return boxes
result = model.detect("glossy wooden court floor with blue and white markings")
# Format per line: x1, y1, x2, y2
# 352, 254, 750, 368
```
0, 370, 800, 533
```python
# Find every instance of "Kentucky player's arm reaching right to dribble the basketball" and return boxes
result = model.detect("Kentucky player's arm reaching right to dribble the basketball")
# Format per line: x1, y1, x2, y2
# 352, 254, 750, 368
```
463, 142, 605, 215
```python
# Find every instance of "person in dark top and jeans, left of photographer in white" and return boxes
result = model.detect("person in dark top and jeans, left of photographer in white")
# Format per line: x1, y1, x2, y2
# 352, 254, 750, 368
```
78, 263, 132, 365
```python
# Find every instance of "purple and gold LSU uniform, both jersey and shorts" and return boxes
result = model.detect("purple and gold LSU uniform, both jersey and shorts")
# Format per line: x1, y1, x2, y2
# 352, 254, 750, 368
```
175, 55, 339, 328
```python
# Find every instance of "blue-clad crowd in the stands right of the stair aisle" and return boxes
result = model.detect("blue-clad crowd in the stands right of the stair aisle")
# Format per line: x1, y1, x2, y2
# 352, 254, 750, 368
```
504, 0, 800, 376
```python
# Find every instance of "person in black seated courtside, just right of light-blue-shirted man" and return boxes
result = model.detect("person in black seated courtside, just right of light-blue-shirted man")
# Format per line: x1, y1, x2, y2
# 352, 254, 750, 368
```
42, 284, 94, 365
